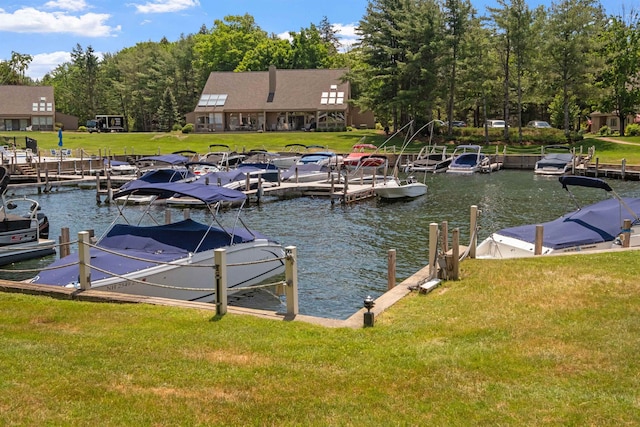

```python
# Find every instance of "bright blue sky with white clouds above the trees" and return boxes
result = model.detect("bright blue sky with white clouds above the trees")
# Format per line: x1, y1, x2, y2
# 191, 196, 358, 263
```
0, 0, 640, 79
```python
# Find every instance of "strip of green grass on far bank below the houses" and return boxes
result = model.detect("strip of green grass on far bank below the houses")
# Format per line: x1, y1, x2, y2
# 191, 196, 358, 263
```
0, 129, 640, 165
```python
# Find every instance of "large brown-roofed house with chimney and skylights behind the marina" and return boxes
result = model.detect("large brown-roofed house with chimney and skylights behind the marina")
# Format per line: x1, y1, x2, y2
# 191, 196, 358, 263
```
187, 66, 375, 132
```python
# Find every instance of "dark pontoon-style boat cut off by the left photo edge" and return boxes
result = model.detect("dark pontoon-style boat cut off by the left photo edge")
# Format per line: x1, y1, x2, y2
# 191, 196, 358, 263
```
0, 166, 56, 265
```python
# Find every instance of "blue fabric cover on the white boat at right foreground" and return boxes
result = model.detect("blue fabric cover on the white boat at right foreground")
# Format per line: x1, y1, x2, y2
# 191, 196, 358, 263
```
498, 197, 640, 249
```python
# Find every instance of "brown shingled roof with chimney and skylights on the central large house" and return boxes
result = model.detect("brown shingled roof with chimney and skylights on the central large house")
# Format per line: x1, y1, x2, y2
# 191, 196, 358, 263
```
194, 68, 350, 112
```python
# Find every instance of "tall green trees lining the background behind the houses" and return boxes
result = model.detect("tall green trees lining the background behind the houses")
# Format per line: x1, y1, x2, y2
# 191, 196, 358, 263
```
0, 0, 640, 137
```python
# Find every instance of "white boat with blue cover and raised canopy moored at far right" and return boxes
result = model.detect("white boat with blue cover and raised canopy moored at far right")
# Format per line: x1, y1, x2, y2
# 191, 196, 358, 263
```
476, 175, 640, 258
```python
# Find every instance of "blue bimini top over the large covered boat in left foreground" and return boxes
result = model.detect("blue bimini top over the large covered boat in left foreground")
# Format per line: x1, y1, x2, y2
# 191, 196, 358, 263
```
113, 180, 247, 205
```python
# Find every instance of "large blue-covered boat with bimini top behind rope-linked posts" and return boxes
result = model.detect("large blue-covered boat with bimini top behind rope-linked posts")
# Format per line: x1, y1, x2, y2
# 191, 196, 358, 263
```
29, 181, 284, 302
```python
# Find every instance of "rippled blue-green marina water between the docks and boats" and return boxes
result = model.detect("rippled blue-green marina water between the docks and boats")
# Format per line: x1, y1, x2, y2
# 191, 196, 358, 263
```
0, 170, 640, 319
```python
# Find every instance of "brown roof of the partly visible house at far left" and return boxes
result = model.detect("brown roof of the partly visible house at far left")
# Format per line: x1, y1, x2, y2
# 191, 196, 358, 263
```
0, 85, 56, 117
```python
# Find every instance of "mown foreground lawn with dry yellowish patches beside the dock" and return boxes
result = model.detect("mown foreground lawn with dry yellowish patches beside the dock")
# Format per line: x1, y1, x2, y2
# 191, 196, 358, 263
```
0, 252, 640, 426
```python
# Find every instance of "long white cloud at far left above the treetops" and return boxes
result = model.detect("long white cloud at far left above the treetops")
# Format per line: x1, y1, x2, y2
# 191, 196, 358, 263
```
0, 7, 121, 37
